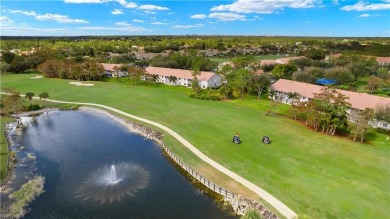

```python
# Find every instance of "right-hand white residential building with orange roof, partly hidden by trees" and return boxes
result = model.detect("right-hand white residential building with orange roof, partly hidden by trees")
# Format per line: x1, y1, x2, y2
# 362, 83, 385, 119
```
271, 79, 390, 130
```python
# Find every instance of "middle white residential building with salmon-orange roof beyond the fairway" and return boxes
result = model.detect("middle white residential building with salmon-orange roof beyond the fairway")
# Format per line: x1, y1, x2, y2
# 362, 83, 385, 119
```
145, 67, 222, 89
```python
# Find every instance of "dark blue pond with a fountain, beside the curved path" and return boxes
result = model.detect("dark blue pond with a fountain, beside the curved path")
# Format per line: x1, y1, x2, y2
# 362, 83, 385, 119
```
3, 111, 237, 219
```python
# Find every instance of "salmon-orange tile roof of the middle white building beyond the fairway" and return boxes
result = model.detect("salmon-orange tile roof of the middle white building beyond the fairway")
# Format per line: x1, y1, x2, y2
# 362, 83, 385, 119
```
146, 67, 215, 81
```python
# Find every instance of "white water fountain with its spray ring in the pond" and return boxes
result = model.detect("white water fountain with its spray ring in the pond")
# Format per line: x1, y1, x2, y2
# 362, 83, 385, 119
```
75, 162, 150, 204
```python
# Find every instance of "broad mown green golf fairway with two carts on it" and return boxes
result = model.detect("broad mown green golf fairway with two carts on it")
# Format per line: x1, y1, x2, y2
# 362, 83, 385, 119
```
1, 74, 390, 218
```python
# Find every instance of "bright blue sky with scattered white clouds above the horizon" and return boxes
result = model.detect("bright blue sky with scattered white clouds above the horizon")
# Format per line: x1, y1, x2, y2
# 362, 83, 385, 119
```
0, 0, 390, 37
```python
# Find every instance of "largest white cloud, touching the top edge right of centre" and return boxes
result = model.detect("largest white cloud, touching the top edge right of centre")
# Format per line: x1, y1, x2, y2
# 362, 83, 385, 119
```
211, 0, 321, 14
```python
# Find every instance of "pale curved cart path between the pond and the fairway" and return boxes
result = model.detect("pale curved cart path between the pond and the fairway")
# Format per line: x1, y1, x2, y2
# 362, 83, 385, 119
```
2, 93, 298, 218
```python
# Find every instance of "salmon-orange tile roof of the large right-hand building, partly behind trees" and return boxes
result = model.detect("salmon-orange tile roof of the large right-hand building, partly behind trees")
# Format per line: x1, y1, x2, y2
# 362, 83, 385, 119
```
271, 79, 390, 110
